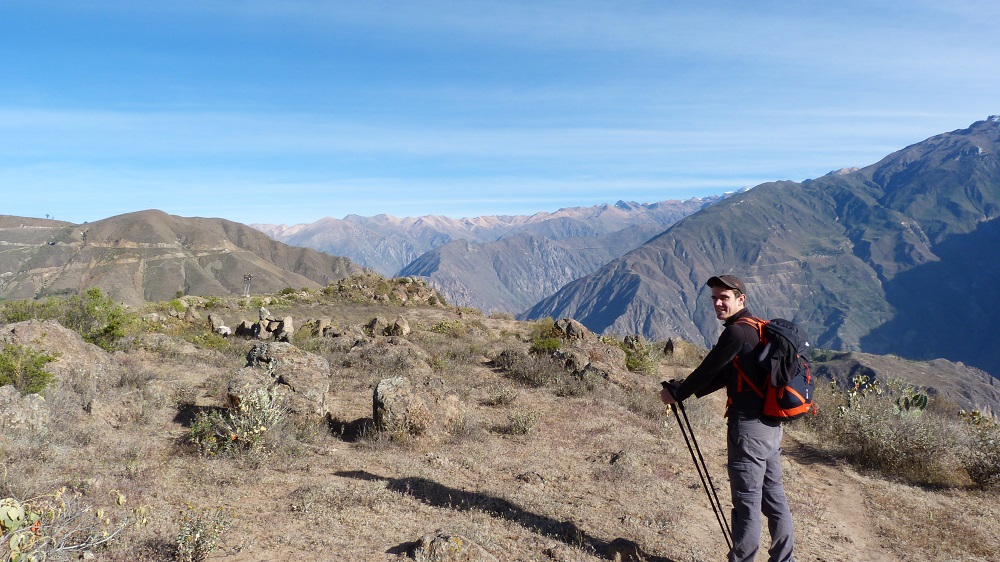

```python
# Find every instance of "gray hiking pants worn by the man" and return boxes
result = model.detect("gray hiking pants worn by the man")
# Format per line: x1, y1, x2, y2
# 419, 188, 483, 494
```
728, 412, 794, 562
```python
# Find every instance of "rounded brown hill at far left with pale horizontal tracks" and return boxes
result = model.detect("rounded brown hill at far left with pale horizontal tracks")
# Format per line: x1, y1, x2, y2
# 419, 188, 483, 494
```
0, 211, 361, 306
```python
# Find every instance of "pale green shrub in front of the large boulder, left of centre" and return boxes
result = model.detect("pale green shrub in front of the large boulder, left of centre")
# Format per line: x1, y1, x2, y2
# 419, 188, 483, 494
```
189, 388, 287, 455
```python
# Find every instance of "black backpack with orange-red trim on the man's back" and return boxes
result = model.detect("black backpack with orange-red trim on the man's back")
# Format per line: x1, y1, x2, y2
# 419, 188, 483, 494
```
733, 317, 816, 421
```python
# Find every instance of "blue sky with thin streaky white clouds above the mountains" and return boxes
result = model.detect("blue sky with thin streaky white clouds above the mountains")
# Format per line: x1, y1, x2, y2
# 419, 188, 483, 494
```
0, 0, 1000, 224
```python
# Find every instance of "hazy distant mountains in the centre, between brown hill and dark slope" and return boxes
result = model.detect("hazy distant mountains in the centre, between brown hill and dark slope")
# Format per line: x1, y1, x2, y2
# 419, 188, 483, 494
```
251, 196, 721, 312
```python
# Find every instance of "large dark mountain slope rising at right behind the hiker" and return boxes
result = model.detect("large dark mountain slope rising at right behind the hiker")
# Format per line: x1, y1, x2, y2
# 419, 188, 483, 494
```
524, 117, 1000, 376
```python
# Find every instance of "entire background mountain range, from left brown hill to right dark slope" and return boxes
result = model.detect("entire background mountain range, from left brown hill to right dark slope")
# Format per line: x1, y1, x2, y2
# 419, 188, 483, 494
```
0, 117, 1000, 377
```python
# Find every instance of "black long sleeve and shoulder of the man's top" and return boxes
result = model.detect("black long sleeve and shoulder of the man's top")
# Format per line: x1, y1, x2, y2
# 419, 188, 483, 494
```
674, 308, 760, 401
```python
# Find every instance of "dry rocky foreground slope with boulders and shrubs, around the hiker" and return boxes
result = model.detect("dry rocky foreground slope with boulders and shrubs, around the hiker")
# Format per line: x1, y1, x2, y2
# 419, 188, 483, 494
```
0, 286, 1000, 562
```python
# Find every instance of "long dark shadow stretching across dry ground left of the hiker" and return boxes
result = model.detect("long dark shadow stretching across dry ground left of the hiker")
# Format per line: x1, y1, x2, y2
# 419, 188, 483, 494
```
336, 470, 674, 562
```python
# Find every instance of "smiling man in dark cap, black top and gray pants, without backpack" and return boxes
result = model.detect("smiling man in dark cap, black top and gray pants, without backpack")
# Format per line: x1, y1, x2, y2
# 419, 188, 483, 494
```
660, 275, 794, 562
